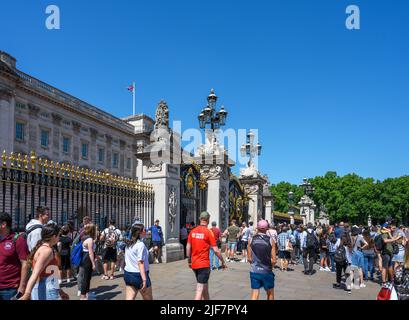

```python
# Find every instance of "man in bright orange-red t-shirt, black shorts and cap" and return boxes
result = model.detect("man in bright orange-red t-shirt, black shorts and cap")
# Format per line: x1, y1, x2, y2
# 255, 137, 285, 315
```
186, 211, 226, 300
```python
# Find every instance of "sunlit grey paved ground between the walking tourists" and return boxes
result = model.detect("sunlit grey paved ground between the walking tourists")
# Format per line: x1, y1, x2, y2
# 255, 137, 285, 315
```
62, 261, 379, 300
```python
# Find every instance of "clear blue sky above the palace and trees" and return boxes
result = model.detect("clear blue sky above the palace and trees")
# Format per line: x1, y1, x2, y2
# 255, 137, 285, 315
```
0, 0, 409, 183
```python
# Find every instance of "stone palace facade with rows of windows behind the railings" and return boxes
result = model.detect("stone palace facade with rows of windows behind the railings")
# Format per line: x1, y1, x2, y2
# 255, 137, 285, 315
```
0, 52, 153, 178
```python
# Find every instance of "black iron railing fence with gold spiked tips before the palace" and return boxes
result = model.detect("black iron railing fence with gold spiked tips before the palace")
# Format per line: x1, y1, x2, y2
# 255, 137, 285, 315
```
0, 152, 154, 230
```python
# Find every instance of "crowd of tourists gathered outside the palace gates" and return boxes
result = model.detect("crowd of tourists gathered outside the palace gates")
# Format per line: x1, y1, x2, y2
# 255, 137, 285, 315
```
0, 207, 409, 300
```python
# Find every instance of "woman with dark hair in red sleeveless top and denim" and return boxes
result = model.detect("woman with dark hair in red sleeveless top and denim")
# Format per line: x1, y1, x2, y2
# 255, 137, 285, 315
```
20, 224, 69, 300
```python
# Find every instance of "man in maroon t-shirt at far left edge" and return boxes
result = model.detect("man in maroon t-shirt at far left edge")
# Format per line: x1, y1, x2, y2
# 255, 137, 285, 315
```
0, 213, 29, 300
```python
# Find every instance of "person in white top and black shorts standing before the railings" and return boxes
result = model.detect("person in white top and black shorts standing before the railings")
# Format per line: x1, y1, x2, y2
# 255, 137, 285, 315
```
100, 220, 122, 280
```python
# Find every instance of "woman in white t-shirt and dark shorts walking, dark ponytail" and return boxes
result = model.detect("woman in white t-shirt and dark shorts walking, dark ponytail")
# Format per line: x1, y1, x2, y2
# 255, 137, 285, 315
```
124, 224, 153, 300
